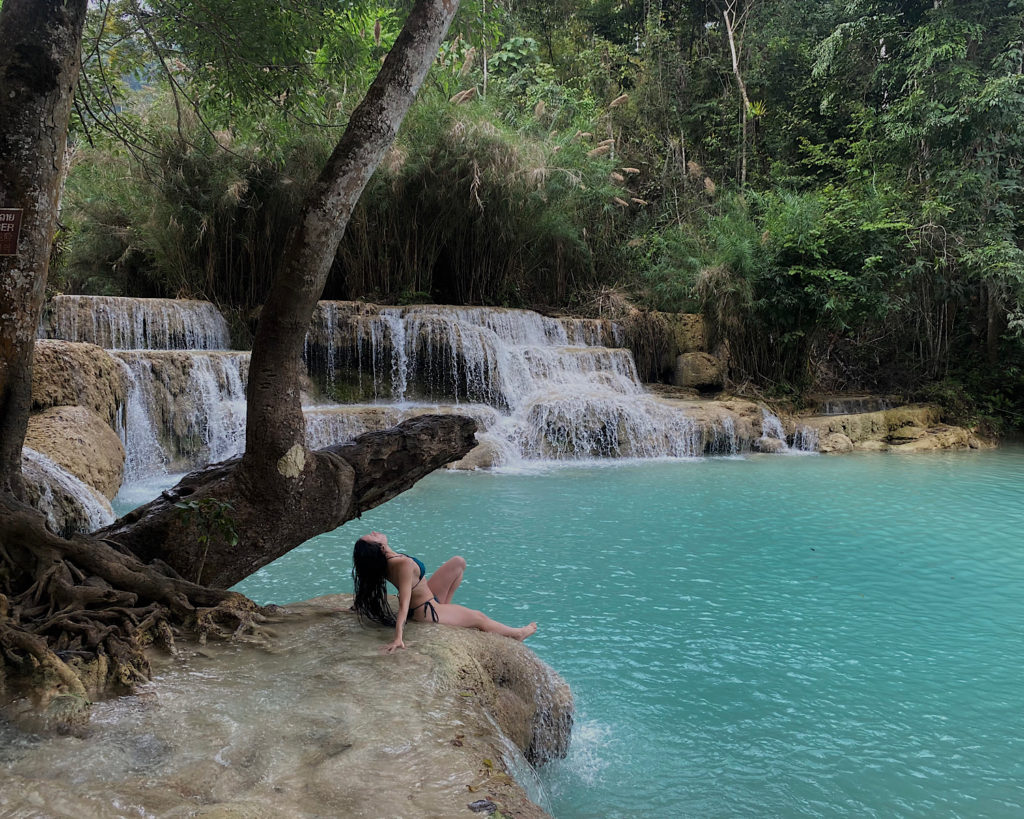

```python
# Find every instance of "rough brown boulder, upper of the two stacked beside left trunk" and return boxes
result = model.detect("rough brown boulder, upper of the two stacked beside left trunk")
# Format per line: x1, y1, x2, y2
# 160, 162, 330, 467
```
32, 339, 125, 428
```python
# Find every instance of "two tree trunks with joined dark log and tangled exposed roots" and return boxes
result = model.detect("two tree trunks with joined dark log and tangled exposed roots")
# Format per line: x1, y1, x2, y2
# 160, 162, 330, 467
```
0, 0, 466, 701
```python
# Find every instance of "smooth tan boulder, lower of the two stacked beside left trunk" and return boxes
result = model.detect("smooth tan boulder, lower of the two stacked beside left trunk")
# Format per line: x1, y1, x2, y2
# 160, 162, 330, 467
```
25, 406, 125, 498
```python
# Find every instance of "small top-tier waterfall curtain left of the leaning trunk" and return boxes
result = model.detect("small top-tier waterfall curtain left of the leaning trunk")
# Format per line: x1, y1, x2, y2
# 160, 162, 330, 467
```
43, 296, 229, 350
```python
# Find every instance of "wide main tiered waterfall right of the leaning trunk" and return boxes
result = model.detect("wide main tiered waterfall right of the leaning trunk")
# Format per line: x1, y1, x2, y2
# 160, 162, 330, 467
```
306, 302, 712, 462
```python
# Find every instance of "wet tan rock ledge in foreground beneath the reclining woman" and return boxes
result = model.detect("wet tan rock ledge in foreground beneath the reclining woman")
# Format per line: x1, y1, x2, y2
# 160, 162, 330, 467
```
0, 595, 572, 819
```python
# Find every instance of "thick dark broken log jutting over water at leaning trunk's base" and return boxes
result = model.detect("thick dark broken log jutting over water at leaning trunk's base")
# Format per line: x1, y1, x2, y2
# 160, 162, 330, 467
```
96, 416, 476, 589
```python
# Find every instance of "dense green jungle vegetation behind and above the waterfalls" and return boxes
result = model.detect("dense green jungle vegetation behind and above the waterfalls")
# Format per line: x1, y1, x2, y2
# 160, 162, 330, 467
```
56, 0, 1024, 424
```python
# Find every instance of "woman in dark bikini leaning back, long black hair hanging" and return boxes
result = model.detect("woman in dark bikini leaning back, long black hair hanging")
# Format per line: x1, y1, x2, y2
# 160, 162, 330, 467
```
352, 531, 537, 654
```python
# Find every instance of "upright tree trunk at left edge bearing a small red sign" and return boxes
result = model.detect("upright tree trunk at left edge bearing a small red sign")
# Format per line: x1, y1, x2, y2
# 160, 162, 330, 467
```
0, 0, 88, 499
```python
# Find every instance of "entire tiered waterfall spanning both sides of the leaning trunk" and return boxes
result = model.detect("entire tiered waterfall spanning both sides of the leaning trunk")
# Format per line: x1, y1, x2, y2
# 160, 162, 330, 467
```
46, 296, 815, 511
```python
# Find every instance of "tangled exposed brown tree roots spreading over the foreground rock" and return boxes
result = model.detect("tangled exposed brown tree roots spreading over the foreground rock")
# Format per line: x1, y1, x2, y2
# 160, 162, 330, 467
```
0, 495, 265, 724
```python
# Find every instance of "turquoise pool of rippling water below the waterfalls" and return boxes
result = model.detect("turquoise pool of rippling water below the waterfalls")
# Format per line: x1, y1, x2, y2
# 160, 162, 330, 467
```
239, 449, 1024, 819
